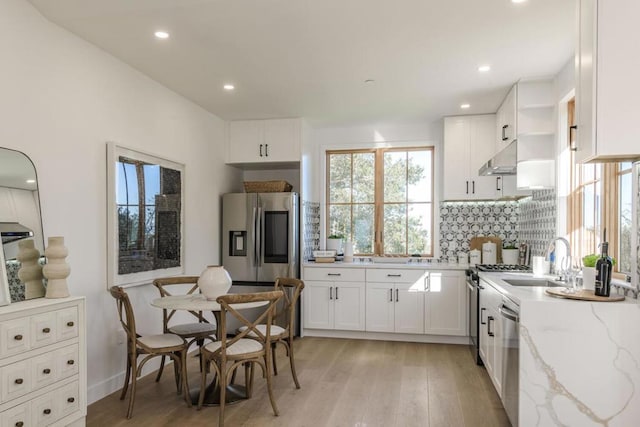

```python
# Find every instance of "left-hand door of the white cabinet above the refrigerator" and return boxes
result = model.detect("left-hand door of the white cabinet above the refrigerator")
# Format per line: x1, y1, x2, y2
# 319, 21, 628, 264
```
227, 120, 264, 163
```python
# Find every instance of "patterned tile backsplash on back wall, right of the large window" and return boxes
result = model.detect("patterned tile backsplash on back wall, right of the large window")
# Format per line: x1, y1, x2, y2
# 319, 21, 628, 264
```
440, 201, 520, 259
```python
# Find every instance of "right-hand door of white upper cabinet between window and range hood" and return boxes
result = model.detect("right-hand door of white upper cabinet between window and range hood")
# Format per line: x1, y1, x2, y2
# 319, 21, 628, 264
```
469, 114, 499, 200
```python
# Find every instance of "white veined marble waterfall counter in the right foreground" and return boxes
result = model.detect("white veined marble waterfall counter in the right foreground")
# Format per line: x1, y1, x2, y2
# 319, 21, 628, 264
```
480, 273, 640, 426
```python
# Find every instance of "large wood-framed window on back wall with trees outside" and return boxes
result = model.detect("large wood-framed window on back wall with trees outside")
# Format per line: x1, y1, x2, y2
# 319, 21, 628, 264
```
327, 147, 433, 256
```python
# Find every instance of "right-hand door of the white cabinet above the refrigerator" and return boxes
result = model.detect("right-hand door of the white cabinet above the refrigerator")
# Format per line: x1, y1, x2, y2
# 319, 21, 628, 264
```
263, 119, 302, 162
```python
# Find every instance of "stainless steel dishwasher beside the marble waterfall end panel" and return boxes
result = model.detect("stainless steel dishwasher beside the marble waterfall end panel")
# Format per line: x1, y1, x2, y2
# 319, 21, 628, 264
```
499, 296, 520, 427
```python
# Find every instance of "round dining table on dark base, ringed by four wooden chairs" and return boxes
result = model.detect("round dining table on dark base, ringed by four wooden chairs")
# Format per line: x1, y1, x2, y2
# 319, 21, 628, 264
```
151, 294, 269, 406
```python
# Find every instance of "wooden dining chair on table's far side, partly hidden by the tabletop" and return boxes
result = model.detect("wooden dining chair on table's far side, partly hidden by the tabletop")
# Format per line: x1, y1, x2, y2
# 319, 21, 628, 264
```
153, 276, 216, 382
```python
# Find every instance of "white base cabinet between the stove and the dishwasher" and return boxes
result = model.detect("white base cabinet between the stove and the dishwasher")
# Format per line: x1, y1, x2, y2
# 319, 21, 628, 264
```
478, 281, 503, 396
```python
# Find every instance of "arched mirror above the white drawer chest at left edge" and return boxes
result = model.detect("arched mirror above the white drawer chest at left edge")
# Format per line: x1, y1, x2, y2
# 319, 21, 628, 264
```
0, 147, 44, 302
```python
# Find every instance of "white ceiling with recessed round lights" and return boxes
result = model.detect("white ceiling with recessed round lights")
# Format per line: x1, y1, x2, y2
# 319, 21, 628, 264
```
30, 0, 576, 127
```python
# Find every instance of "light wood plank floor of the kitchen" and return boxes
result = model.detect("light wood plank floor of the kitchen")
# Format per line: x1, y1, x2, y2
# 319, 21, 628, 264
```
87, 337, 509, 427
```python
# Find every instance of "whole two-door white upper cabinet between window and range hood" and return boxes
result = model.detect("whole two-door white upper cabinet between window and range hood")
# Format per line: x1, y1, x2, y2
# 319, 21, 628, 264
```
443, 114, 500, 200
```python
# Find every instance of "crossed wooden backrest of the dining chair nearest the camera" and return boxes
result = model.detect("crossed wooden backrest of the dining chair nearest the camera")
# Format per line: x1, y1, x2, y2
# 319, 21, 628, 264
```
216, 291, 283, 353
